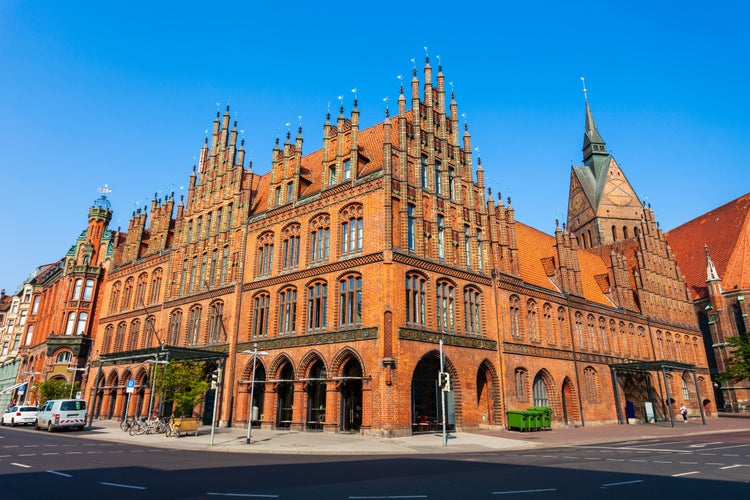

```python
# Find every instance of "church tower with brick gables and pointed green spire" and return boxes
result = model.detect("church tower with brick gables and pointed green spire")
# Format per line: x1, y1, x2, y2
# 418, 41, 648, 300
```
568, 87, 643, 248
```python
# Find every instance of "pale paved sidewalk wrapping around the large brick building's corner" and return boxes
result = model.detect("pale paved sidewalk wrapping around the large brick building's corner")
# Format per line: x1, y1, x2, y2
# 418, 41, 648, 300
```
76, 417, 750, 455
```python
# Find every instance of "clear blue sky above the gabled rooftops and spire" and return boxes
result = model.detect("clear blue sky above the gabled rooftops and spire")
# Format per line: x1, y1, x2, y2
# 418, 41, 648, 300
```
0, 0, 750, 292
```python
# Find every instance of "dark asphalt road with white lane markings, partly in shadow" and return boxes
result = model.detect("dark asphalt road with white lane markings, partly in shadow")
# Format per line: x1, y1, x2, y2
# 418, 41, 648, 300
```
0, 428, 750, 500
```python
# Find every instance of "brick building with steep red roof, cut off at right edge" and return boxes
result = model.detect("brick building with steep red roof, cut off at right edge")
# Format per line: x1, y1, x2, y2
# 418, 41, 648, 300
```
667, 193, 750, 412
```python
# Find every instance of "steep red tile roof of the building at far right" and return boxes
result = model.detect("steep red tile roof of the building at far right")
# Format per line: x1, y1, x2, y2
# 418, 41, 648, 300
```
667, 193, 750, 299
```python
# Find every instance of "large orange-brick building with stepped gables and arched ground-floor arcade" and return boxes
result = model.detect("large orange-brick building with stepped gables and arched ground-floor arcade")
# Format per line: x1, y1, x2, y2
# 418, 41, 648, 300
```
87, 60, 712, 436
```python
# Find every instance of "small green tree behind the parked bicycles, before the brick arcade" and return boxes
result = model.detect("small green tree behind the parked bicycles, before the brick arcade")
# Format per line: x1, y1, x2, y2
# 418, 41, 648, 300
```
154, 361, 208, 417
